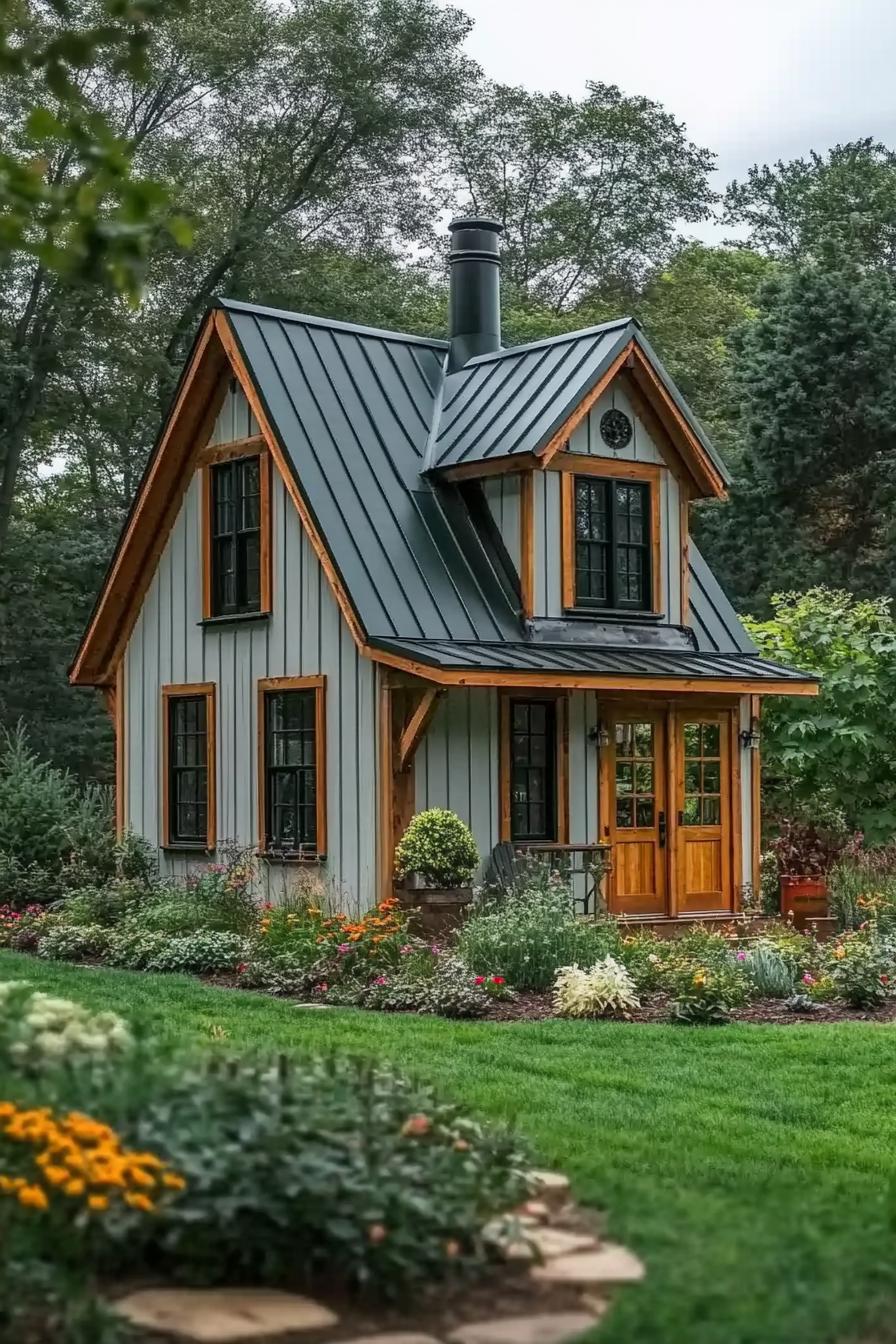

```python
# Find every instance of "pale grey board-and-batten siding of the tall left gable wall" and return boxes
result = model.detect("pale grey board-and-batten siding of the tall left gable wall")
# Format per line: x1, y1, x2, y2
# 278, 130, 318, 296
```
125, 387, 376, 910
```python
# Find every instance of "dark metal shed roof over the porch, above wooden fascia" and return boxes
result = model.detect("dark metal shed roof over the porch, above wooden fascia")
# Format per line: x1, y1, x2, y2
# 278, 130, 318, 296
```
376, 640, 817, 683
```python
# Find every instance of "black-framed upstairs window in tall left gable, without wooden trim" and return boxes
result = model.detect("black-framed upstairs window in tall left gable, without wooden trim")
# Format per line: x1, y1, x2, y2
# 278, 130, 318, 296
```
211, 457, 262, 616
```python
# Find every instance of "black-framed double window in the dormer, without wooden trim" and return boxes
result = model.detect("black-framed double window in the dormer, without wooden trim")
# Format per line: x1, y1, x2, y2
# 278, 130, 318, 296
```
574, 476, 653, 612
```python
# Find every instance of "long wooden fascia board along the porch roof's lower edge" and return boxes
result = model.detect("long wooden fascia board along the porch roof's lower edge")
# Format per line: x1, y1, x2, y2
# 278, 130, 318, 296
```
361, 645, 818, 695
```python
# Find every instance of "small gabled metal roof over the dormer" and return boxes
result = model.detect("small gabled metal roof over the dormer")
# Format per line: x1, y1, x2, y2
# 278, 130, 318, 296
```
427, 317, 731, 495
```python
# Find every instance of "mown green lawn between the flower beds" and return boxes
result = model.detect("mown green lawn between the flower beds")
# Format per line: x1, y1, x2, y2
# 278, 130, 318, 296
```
0, 953, 896, 1344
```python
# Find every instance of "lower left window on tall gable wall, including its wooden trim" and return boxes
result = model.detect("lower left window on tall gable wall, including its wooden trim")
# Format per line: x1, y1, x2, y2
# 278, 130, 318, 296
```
163, 683, 215, 849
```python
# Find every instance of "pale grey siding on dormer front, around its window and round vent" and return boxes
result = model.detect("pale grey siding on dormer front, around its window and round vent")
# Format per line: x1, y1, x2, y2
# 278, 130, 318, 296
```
526, 384, 681, 625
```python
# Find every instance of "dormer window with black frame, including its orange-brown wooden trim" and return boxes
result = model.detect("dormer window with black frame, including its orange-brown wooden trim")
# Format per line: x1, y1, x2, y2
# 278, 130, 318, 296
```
562, 454, 660, 616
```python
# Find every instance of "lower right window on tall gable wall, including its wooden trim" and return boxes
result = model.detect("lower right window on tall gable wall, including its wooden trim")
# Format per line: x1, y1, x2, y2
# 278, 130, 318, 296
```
258, 677, 326, 859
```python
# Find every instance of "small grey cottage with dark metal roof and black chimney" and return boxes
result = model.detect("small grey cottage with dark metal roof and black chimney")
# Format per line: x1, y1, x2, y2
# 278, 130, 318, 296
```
71, 219, 817, 919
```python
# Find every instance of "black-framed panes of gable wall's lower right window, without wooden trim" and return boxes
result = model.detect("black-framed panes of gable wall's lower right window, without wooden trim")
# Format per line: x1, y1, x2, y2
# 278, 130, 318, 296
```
265, 688, 320, 853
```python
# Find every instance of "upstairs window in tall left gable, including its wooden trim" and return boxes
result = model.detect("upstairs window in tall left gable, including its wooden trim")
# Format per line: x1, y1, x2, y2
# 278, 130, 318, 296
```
204, 453, 270, 618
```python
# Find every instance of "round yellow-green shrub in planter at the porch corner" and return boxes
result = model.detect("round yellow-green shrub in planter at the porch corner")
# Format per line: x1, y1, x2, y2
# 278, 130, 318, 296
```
395, 808, 480, 933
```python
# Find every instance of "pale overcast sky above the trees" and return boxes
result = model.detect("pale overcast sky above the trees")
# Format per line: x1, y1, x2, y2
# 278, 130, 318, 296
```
457, 0, 896, 237
